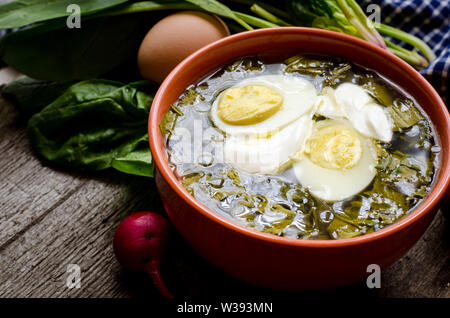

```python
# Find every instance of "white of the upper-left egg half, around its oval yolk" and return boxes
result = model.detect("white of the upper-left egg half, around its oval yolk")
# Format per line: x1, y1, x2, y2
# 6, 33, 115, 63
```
210, 75, 317, 135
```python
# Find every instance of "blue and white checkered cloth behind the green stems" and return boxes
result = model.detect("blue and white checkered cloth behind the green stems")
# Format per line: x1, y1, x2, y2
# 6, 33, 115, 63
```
0, 0, 450, 101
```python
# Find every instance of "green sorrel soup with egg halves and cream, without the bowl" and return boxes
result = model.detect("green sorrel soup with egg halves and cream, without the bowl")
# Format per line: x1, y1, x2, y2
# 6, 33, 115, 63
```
160, 55, 440, 239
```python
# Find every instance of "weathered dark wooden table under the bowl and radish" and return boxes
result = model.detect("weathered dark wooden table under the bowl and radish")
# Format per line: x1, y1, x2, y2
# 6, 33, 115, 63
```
0, 69, 450, 297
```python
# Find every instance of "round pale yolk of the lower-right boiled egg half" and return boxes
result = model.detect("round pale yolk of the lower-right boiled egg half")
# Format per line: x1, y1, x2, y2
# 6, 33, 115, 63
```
305, 126, 362, 170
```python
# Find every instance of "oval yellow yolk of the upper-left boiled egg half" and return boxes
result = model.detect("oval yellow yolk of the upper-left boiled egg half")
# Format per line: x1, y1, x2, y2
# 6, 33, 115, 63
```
217, 85, 283, 125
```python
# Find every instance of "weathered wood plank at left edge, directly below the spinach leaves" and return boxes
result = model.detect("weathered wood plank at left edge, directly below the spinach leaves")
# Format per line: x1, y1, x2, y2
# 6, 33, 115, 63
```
0, 93, 86, 250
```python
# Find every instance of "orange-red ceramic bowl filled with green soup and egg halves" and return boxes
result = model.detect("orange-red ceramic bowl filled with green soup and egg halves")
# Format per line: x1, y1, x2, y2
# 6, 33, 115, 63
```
149, 28, 449, 289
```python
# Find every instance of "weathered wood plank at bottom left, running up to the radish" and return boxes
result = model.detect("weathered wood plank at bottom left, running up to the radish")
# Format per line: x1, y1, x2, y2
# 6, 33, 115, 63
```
0, 169, 163, 297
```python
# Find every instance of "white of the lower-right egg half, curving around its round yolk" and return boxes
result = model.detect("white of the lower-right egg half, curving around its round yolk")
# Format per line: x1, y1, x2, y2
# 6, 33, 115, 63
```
293, 120, 377, 202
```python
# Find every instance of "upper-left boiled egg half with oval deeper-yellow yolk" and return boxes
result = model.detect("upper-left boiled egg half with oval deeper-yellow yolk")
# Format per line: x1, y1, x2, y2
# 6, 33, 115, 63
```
210, 75, 317, 136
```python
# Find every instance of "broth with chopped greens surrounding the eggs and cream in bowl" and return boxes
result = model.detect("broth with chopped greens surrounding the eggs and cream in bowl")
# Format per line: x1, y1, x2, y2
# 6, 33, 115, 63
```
160, 55, 440, 239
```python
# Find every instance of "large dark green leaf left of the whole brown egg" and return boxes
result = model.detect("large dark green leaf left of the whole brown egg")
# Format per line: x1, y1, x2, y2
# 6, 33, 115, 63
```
0, 14, 153, 82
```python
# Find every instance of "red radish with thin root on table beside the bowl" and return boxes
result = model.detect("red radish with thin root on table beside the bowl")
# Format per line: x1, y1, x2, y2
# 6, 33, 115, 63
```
113, 212, 174, 298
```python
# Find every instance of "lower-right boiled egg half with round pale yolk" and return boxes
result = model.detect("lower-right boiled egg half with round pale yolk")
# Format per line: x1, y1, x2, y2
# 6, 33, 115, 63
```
294, 119, 377, 201
